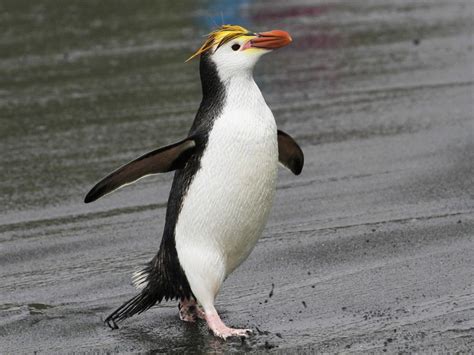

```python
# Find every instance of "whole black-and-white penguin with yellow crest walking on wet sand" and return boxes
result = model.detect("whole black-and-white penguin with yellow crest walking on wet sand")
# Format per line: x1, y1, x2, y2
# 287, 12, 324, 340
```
85, 25, 304, 339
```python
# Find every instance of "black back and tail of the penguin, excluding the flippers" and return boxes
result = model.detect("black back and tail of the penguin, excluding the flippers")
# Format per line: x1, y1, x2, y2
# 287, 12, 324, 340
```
105, 52, 226, 328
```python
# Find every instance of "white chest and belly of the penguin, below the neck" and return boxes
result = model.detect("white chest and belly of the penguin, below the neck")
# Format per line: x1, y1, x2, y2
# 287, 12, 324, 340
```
175, 98, 278, 298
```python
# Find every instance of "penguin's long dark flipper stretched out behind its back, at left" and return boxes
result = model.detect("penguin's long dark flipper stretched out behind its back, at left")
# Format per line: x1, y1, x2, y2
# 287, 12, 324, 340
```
84, 137, 197, 203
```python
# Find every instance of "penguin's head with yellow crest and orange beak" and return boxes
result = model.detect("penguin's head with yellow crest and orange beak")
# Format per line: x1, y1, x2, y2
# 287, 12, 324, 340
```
188, 25, 292, 78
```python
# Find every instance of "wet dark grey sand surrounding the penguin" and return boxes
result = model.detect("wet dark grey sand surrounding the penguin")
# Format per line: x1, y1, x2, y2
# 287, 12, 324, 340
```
0, 0, 474, 353
